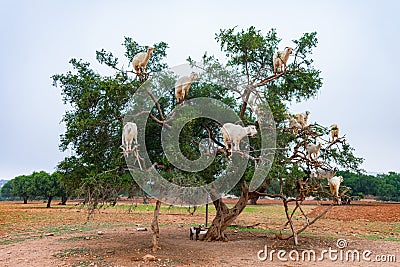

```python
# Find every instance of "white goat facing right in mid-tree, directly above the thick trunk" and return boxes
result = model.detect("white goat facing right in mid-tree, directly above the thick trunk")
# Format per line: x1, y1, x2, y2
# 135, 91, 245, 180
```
221, 123, 257, 151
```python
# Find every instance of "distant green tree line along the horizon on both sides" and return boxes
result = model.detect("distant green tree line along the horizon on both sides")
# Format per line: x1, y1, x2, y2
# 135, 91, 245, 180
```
0, 171, 400, 208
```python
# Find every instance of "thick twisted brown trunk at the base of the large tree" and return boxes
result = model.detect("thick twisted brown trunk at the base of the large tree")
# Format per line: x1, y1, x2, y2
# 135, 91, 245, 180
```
204, 182, 249, 241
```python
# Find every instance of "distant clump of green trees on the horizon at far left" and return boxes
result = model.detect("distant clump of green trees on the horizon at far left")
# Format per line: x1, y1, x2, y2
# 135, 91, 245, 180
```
0, 171, 67, 208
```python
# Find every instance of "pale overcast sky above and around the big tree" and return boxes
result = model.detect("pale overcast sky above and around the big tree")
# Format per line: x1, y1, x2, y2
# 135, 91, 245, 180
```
0, 0, 400, 179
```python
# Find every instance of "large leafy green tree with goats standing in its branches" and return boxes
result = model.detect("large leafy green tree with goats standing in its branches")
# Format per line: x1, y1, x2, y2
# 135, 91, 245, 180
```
52, 27, 362, 248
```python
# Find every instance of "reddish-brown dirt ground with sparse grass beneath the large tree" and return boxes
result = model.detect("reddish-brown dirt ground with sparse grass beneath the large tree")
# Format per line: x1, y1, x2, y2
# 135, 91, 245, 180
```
0, 201, 400, 267
